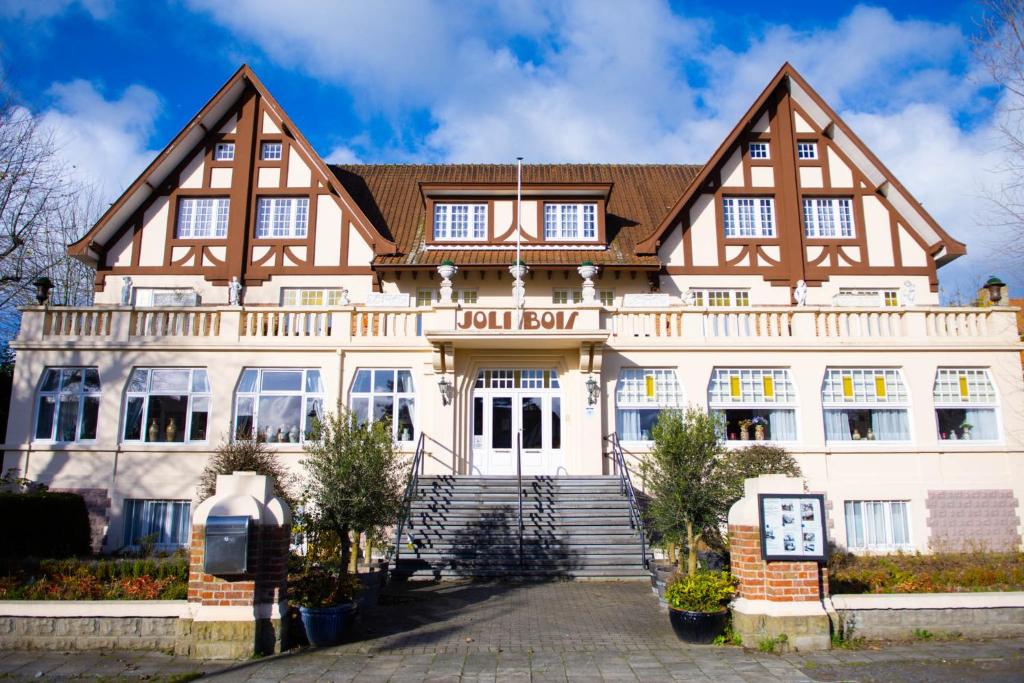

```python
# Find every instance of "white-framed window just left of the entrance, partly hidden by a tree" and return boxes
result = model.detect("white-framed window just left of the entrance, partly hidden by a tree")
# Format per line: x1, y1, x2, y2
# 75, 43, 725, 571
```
351, 368, 416, 441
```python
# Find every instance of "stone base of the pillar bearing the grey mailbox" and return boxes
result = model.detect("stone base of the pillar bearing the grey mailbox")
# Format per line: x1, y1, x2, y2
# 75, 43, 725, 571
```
174, 618, 284, 659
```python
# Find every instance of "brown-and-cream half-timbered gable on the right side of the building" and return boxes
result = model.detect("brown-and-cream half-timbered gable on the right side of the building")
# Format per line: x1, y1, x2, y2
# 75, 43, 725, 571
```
639, 65, 964, 303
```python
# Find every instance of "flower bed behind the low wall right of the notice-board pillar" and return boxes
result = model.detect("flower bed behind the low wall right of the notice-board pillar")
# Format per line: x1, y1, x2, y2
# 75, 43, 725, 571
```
828, 551, 1024, 595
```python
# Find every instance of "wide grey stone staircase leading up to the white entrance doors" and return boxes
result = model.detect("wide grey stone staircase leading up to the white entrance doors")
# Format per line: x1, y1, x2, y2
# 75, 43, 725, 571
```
391, 475, 650, 581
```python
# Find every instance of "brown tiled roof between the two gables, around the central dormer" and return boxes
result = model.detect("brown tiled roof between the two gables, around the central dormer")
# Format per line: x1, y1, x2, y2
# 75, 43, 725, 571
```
331, 164, 700, 267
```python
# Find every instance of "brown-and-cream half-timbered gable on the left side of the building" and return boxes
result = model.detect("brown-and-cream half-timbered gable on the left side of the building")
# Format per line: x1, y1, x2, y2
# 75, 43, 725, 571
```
71, 67, 393, 303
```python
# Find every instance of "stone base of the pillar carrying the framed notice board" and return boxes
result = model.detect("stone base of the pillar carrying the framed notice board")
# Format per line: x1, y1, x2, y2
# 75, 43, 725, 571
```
732, 598, 831, 652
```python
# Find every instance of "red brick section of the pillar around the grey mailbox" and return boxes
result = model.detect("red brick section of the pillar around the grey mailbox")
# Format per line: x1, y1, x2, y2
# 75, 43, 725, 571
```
188, 526, 290, 607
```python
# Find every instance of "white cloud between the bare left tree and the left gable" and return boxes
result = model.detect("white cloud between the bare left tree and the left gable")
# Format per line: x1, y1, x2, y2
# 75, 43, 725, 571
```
38, 80, 160, 201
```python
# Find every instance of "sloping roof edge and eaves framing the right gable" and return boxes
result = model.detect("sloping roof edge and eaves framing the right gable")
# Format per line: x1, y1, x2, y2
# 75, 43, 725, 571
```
637, 62, 967, 265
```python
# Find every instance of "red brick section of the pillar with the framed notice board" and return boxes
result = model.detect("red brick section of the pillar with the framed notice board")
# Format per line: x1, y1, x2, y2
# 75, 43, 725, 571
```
729, 524, 828, 602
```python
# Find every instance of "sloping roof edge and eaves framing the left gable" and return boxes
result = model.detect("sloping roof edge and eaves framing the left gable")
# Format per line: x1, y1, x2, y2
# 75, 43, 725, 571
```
68, 65, 394, 264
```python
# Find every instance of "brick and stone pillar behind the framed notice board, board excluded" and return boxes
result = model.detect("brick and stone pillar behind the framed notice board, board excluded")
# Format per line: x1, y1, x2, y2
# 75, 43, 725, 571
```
729, 475, 831, 650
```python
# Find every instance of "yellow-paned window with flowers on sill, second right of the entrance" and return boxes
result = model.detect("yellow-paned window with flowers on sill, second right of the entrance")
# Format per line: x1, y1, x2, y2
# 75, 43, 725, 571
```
708, 368, 797, 441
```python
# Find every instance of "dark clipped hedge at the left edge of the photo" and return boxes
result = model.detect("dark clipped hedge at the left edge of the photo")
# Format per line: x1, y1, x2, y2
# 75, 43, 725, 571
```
0, 492, 92, 557
